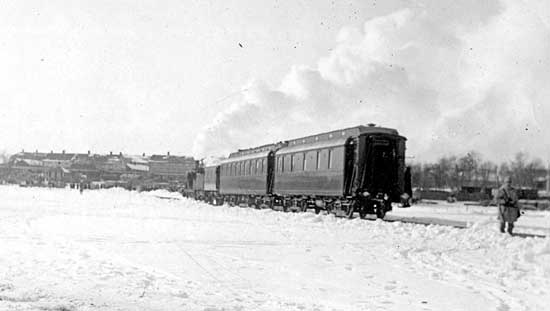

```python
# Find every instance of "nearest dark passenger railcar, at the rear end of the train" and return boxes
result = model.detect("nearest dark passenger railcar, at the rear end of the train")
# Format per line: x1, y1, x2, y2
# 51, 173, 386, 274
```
273, 125, 406, 217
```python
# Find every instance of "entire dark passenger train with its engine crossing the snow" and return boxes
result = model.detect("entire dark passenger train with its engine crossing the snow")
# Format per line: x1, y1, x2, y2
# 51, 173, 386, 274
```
184, 124, 412, 218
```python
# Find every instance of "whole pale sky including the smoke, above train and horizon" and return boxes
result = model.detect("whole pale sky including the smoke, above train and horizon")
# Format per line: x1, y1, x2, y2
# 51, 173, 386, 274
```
0, 0, 550, 165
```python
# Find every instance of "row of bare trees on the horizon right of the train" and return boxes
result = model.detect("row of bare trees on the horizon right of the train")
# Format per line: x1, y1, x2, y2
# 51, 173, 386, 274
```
411, 151, 546, 189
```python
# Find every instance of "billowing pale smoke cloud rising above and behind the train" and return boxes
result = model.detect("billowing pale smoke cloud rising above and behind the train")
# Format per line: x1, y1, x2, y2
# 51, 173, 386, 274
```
194, 0, 550, 165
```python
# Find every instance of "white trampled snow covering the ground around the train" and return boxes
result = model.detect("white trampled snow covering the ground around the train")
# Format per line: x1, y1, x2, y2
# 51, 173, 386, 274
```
0, 186, 550, 311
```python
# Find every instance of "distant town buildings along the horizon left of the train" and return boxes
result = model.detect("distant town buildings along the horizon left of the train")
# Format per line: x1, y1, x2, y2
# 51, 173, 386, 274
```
0, 150, 197, 188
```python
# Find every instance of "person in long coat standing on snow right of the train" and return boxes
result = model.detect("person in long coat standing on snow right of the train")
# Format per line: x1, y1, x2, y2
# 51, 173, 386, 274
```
496, 177, 519, 234
